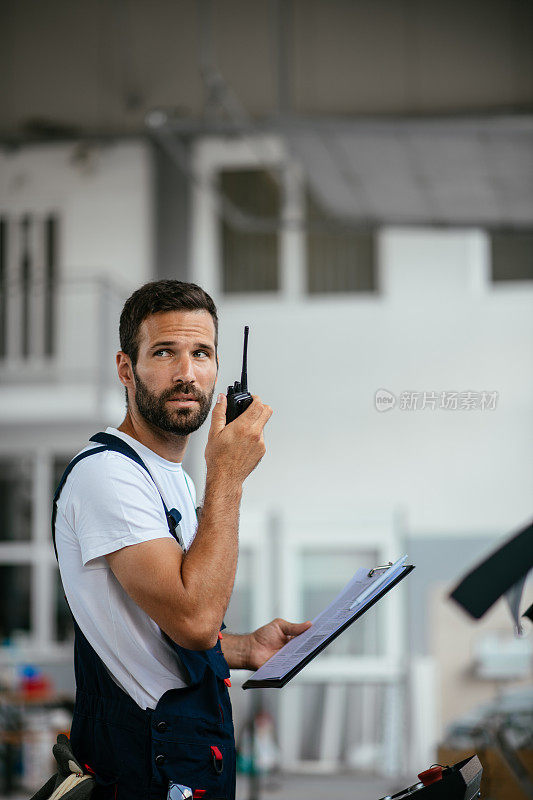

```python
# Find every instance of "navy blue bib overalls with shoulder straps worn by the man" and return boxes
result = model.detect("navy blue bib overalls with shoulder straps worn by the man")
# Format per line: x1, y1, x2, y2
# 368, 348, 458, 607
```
52, 433, 235, 800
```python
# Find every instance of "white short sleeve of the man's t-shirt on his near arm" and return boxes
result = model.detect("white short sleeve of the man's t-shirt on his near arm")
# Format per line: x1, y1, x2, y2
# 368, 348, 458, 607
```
63, 453, 172, 566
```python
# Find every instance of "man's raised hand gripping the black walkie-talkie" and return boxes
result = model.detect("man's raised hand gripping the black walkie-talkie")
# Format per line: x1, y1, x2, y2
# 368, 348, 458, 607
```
205, 394, 272, 484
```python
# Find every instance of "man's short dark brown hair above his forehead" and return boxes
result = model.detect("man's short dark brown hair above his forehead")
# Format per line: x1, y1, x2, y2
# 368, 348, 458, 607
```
119, 280, 218, 366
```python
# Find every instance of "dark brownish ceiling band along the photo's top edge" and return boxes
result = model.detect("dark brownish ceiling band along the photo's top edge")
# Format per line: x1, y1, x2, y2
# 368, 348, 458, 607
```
0, 0, 533, 140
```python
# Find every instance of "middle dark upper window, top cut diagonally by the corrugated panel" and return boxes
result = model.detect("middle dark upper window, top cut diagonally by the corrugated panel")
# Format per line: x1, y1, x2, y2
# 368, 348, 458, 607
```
306, 192, 377, 294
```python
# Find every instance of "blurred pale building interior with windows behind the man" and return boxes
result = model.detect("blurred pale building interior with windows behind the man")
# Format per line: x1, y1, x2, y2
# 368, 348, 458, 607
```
0, 0, 533, 797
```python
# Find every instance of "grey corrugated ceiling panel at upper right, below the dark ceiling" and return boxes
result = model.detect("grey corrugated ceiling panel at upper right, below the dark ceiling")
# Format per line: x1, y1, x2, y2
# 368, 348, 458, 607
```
291, 115, 533, 225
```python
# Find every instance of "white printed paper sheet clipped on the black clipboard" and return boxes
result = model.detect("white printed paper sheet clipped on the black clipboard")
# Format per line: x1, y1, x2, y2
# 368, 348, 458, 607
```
250, 556, 407, 681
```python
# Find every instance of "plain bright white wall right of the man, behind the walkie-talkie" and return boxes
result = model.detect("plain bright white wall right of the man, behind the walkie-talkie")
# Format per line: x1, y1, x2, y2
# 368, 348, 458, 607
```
187, 229, 533, 535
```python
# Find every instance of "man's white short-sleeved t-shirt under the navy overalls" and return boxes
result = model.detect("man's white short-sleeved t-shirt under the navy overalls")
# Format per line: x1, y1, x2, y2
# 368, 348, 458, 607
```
56, 428, 197, 709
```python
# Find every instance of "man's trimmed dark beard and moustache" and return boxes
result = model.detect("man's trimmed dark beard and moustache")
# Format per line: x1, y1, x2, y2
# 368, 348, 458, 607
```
133, 367, 215, 436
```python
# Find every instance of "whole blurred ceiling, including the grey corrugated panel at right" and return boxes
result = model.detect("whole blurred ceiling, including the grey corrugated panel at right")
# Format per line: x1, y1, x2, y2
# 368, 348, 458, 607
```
0, 0, 533, 226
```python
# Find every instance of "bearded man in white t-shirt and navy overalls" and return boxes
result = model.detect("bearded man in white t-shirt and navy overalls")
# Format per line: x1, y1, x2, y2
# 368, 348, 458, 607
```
54, 281, 310, 800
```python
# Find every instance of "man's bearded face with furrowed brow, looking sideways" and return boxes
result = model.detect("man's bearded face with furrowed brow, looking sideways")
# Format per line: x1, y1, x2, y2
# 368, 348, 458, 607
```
130, 311, 217, 436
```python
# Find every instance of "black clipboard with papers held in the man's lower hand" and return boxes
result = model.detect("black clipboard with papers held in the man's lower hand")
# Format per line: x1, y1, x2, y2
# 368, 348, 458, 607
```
242, 556, 415, 689
